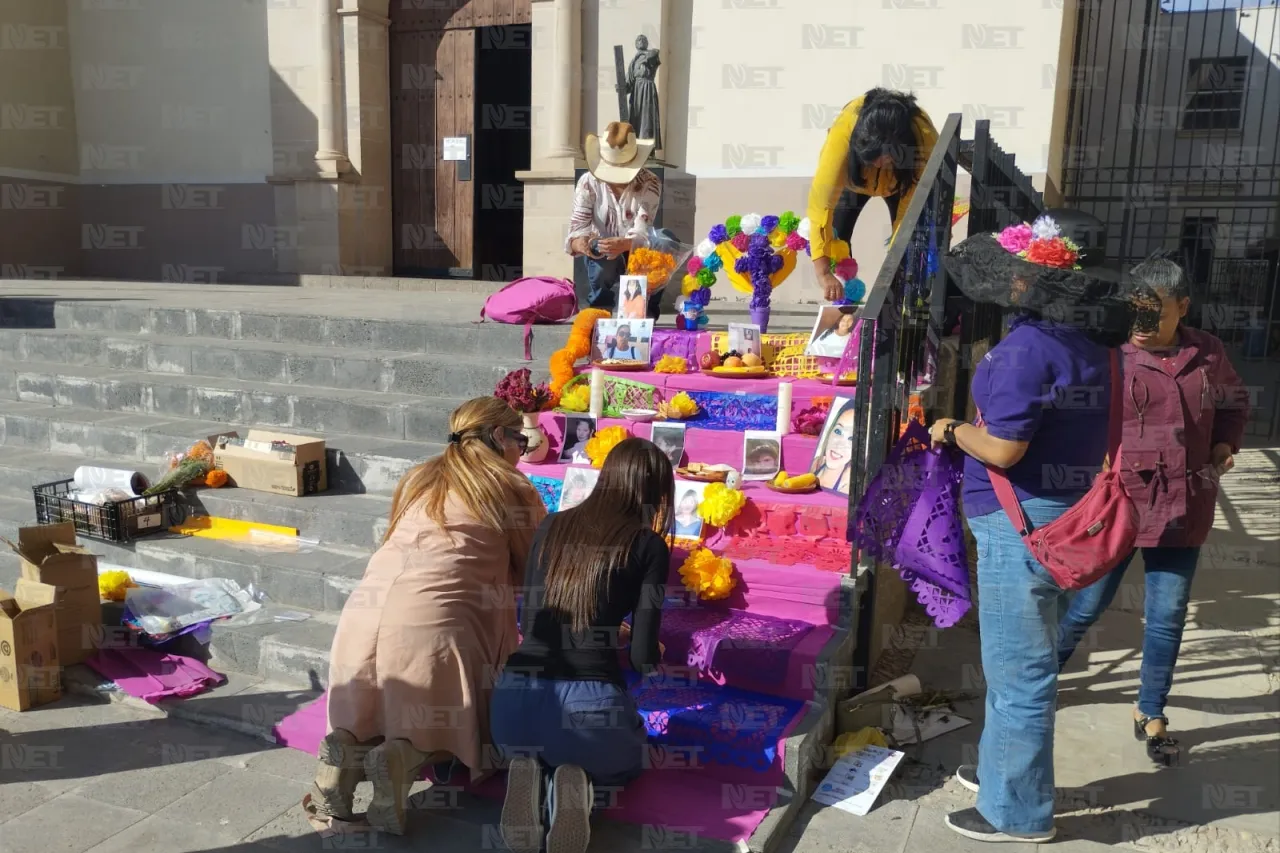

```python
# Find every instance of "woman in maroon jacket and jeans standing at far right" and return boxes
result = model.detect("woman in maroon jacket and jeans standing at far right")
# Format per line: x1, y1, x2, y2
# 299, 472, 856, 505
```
1059, 259, 1249, 765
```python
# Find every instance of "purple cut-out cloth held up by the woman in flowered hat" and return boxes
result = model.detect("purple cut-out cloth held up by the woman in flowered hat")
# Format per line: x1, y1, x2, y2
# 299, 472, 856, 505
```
850, 421, 972, 628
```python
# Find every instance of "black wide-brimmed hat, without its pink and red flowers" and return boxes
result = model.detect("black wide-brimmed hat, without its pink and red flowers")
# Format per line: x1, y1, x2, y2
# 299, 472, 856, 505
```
943, 210, 1135, 346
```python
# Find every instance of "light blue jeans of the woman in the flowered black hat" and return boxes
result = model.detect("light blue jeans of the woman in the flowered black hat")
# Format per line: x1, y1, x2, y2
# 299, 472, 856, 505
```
969, 498, 1070, 833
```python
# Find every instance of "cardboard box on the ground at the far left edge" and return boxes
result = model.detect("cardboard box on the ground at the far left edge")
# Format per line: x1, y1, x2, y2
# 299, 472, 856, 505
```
0, 578, 63, 711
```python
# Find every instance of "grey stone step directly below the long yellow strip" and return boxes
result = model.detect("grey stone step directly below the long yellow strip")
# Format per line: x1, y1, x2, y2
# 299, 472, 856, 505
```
0, 496, 369, 613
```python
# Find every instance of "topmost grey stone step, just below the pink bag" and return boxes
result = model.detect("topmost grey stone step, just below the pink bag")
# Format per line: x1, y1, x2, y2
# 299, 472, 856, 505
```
0, 295, 570, 361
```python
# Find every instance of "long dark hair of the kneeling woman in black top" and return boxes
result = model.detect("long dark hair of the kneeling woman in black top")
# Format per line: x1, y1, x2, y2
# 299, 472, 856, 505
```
541, 438, 676, 631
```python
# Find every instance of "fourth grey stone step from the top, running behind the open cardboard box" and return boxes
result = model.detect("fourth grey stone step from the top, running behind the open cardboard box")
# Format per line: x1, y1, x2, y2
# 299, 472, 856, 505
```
0, 400, 432, 494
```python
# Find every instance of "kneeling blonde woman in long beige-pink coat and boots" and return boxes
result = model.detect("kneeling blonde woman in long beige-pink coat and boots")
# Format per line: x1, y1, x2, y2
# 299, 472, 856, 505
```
303, 397, 545, 835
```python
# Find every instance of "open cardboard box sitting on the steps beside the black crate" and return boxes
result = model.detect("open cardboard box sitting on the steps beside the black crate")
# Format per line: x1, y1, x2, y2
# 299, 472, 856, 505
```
209, 429, 329, 497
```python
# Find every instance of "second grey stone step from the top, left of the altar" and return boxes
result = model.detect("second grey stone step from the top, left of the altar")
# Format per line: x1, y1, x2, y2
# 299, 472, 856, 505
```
0, 329, 549, 398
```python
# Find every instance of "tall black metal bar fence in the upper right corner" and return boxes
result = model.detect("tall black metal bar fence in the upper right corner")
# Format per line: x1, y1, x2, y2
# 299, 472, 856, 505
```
1062, 0, 1280, 362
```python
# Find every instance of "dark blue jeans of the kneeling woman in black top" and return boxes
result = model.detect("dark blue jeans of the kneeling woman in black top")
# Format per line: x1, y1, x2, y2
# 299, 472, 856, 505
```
489, 670, 649, 806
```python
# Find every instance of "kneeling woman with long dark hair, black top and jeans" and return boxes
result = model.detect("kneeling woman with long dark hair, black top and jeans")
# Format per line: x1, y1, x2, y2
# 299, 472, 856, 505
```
490, 438, 676, 853
